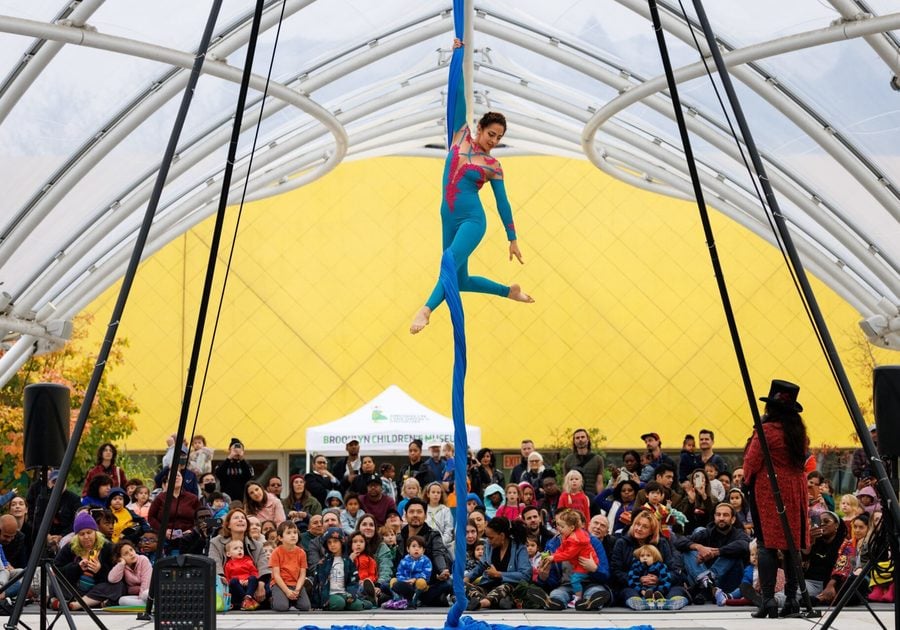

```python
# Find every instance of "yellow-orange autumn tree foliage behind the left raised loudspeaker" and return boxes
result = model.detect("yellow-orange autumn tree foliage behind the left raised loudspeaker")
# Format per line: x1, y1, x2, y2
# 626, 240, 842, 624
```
0, 315, 138, 490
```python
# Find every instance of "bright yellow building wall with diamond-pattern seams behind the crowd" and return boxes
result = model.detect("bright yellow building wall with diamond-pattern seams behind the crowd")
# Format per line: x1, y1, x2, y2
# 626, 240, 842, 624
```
81, 157, 888, 451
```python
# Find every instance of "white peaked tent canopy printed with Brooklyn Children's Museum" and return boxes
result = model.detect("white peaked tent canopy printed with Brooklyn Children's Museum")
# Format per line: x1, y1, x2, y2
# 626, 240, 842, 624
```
306, 385, 481, 460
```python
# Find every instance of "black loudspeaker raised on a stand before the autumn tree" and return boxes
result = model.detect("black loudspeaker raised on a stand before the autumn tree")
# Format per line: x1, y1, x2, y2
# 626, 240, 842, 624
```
24, 383, 69, 468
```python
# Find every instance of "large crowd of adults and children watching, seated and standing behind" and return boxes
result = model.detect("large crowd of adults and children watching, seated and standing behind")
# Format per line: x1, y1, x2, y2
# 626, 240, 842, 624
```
0, 430, 893, 611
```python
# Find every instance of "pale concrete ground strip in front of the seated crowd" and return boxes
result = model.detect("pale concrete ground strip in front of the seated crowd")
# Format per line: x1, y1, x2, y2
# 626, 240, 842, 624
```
0, 604, 894, 630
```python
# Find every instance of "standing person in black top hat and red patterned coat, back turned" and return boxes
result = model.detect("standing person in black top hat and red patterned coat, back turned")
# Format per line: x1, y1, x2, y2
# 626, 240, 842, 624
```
744, 380, 809, 618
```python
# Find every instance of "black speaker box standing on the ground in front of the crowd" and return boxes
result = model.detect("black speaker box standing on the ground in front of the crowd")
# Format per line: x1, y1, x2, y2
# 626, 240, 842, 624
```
153, 554, 216, 630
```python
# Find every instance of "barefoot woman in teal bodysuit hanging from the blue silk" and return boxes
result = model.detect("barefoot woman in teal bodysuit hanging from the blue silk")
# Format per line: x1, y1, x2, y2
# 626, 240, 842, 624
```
409, 39, 534, 334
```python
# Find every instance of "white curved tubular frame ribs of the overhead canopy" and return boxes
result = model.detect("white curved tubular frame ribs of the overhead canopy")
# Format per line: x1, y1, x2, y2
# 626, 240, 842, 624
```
0, 0, 900, 382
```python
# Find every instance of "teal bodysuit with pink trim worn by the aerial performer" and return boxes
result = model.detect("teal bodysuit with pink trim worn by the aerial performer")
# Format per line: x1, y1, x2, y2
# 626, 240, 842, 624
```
425, 81, 516, 310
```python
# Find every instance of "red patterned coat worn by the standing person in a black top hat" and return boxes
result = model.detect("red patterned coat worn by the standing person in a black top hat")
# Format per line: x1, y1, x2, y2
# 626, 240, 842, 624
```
744, 422, 809, 549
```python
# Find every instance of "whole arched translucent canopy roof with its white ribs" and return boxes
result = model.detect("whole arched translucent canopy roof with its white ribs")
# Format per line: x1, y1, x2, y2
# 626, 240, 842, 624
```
0, 0, 900, 382
